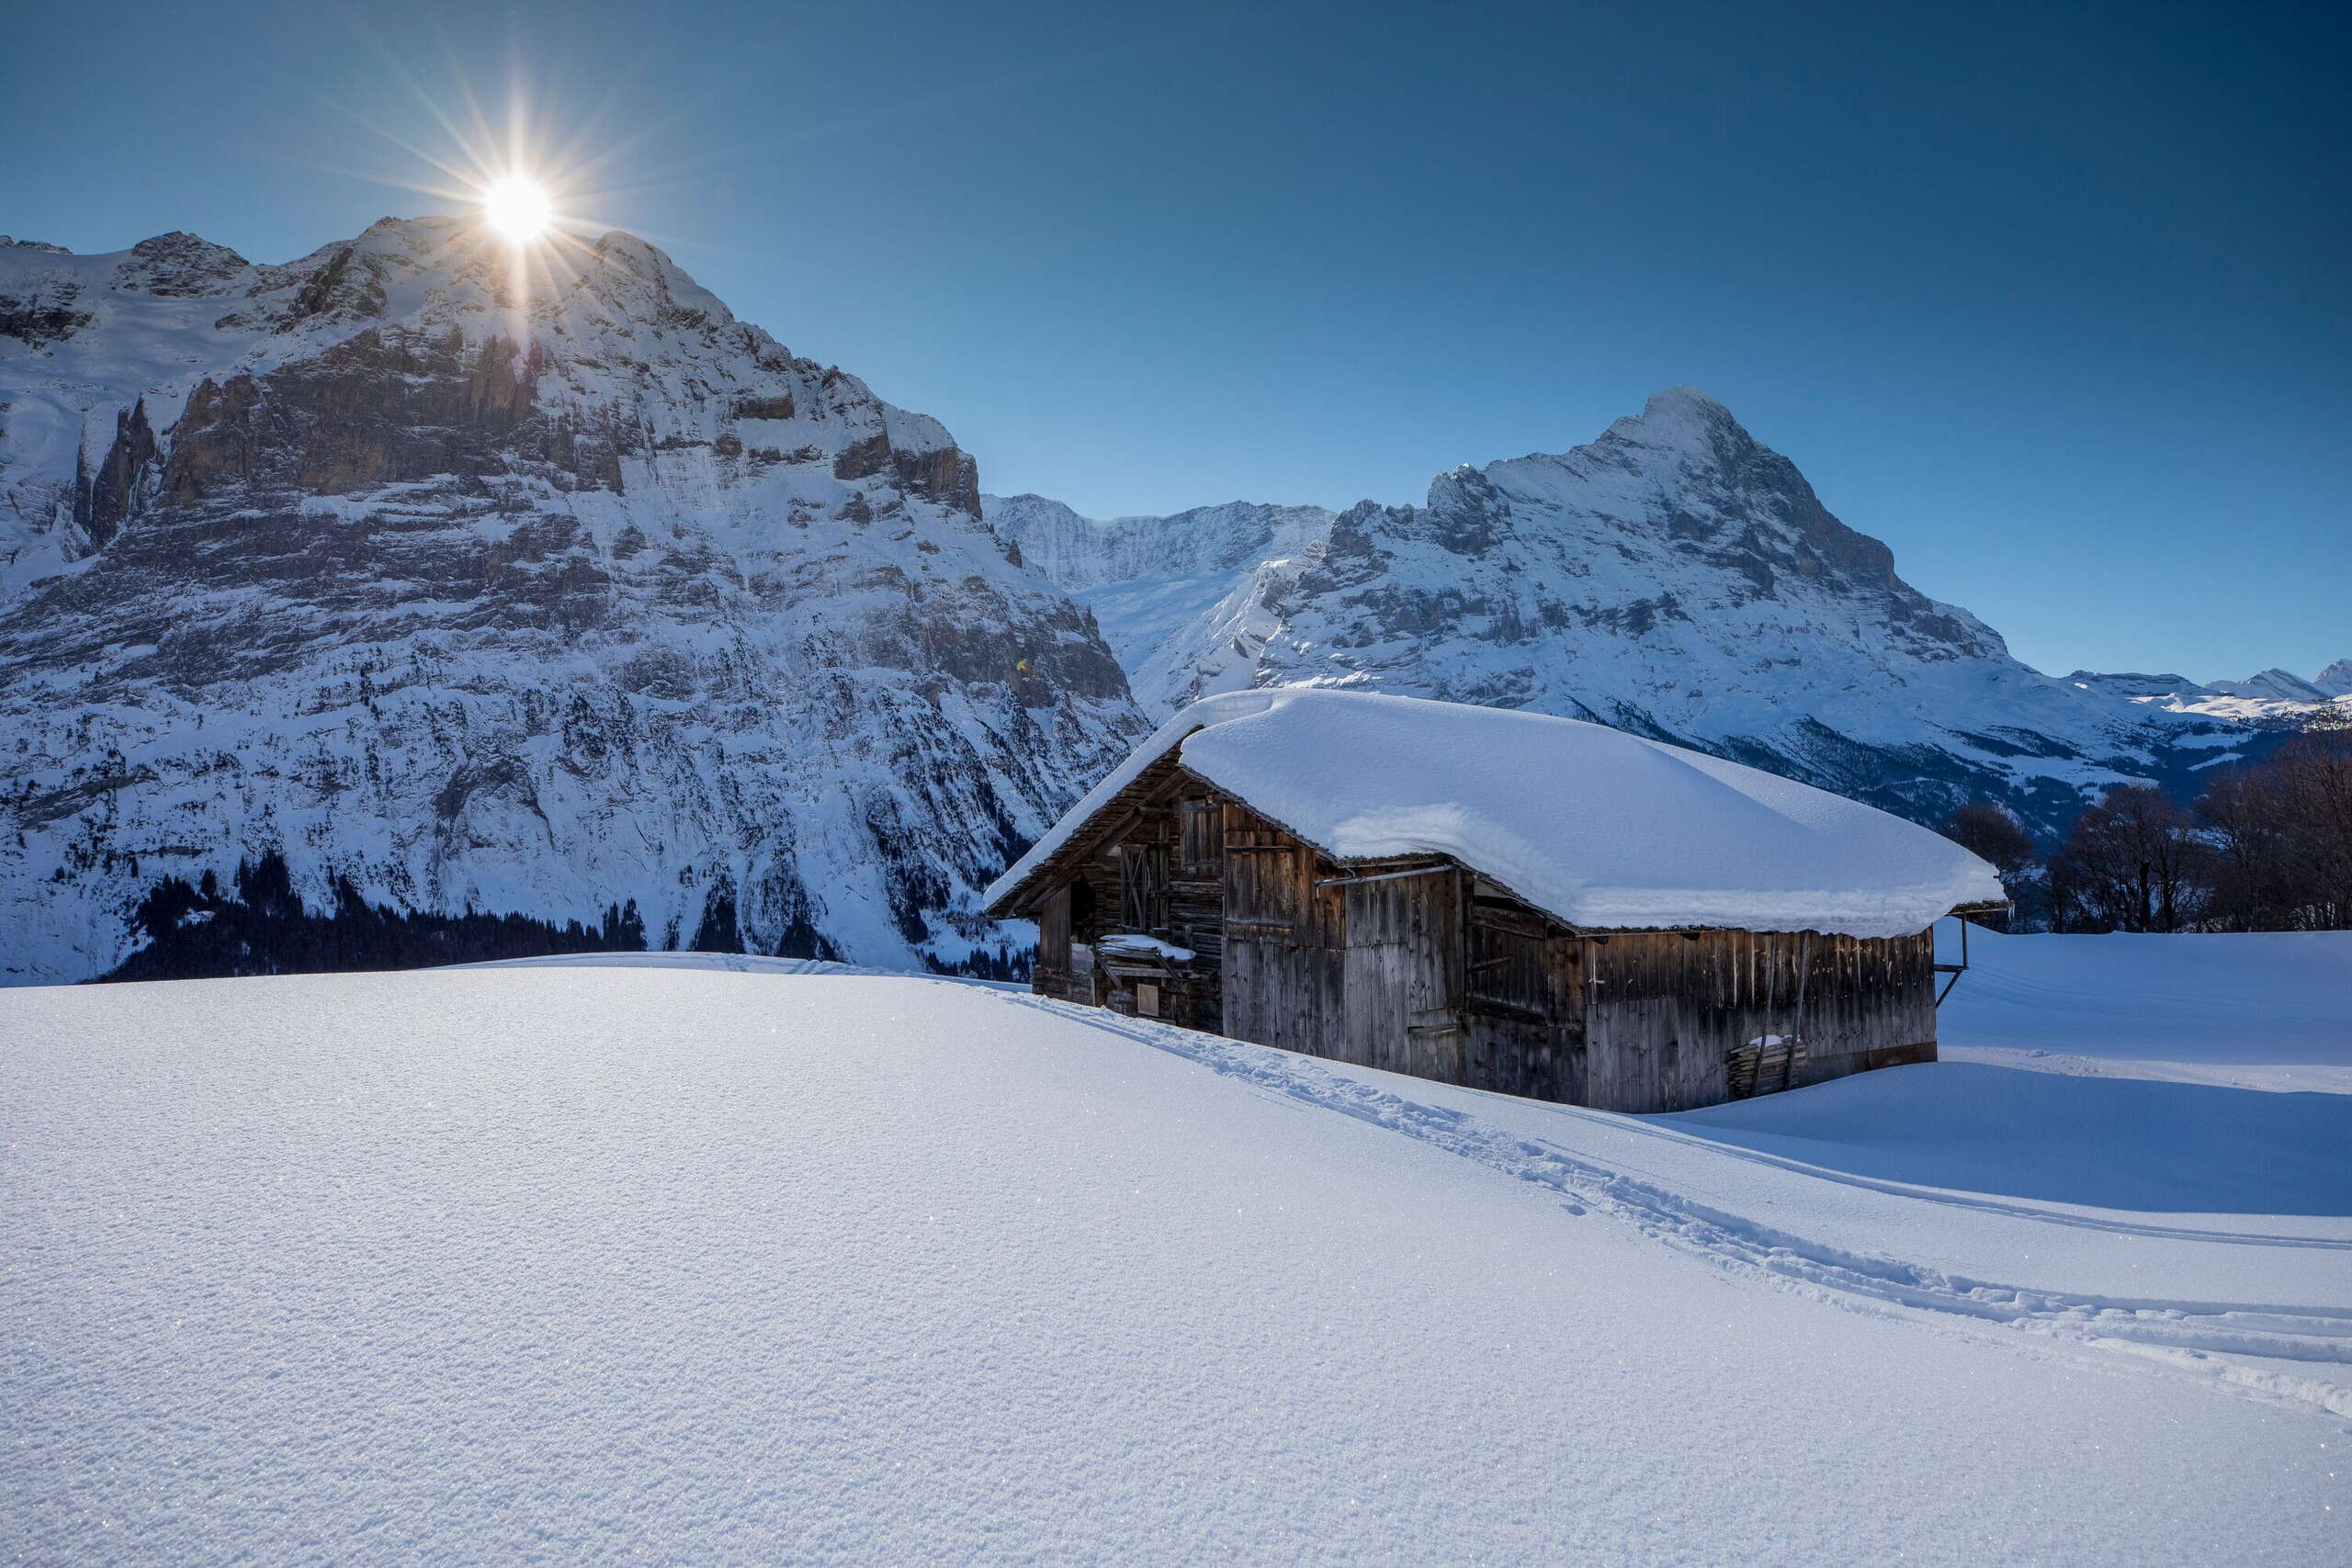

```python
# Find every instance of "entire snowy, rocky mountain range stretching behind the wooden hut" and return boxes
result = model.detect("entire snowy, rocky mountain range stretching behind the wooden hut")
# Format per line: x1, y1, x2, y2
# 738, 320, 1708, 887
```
0, 219, 2324, 980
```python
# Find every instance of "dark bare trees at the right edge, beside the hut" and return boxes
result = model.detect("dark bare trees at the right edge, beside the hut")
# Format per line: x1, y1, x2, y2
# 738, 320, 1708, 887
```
1943, 717, 2352, 931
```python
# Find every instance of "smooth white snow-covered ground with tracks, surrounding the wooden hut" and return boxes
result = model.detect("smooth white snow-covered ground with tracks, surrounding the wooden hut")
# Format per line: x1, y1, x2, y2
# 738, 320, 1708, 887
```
0, 938, 2352, 1565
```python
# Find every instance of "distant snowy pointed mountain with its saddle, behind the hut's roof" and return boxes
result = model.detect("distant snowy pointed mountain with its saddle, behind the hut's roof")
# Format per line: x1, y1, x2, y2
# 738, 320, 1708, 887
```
986, 388, 2304, 832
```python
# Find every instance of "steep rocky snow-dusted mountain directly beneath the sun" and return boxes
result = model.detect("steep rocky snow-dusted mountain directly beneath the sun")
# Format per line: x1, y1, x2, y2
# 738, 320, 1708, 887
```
0, 219, 1143, 980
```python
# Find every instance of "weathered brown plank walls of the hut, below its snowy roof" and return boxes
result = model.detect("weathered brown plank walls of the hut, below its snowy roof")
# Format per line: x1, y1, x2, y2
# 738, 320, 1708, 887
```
1035, 764, 1936, 1112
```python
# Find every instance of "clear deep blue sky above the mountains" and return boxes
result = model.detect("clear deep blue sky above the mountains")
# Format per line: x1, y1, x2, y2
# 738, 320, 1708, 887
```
0, 0, 2352, 680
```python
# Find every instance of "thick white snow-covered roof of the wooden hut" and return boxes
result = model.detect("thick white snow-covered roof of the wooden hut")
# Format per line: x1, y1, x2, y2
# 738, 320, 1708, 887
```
983, 686, 2007, 936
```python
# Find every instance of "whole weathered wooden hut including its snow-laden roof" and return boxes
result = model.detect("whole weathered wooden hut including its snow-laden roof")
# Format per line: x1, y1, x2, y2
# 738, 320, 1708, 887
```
988, 691, 2002, 1112
